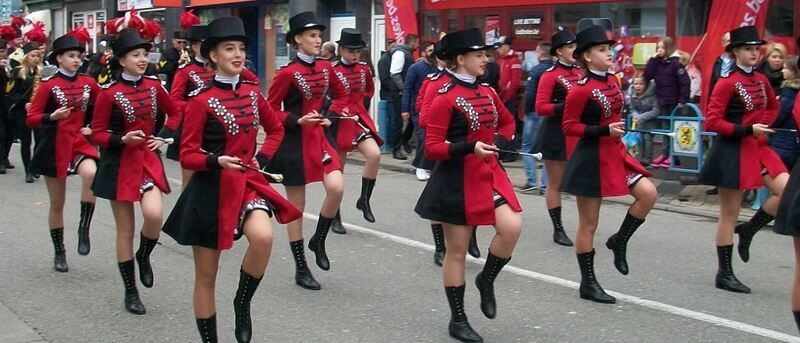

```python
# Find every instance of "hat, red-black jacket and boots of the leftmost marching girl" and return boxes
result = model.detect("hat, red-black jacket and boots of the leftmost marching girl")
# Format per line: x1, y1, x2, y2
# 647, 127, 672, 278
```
27, 34, 100, 271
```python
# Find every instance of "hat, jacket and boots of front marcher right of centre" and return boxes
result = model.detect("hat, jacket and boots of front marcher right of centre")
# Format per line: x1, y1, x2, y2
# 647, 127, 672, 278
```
414, 29, 522, 342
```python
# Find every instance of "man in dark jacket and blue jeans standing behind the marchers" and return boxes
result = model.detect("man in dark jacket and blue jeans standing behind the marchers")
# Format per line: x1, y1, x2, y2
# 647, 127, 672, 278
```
520, 42, 554, 194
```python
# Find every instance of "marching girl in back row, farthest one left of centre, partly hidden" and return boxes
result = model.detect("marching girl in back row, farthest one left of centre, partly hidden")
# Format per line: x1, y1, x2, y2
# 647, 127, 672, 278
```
330, 29, 383, 223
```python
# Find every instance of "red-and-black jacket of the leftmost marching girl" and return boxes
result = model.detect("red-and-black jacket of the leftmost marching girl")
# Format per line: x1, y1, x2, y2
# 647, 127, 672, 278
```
26, 72, 100, 179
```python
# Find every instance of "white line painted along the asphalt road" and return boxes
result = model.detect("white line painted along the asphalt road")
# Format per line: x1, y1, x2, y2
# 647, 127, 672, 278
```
304, 213, 800, 342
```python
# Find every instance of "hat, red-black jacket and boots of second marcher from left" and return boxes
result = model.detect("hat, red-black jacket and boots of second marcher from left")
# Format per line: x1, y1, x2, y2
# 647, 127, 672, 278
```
92, 30, 178, 314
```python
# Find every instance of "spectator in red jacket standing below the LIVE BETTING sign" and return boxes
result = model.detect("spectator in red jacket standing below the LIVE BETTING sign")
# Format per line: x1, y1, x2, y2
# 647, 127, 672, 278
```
494, 36, 522, 162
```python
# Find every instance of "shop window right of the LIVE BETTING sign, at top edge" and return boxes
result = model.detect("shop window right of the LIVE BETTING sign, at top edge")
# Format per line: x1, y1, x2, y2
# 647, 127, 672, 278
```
553, 0, 667, 36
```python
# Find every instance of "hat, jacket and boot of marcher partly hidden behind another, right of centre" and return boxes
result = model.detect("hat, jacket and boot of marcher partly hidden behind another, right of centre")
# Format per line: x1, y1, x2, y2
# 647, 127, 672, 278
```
530, 30, 584, 246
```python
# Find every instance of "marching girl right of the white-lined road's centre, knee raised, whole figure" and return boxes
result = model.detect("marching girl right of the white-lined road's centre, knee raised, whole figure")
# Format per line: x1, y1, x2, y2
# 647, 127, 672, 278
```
561, 26, 656, 303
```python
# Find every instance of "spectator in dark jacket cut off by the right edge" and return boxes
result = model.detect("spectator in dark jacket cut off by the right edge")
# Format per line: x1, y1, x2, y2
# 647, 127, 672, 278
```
769, 56, 800, 170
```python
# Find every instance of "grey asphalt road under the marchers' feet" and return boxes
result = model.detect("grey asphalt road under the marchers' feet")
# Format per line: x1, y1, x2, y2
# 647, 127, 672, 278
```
0, 155, 798, 342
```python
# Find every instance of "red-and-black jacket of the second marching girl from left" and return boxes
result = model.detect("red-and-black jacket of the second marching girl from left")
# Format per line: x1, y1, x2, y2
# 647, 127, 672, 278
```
92, 76, 179, 202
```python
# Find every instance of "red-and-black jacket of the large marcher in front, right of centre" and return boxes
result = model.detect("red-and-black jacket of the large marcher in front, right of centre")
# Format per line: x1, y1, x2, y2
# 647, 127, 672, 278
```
415, 79, 522, 225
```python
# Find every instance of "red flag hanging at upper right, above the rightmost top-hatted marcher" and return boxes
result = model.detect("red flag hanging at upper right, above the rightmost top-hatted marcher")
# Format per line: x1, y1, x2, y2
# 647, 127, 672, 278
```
694, 0, 769, 112
